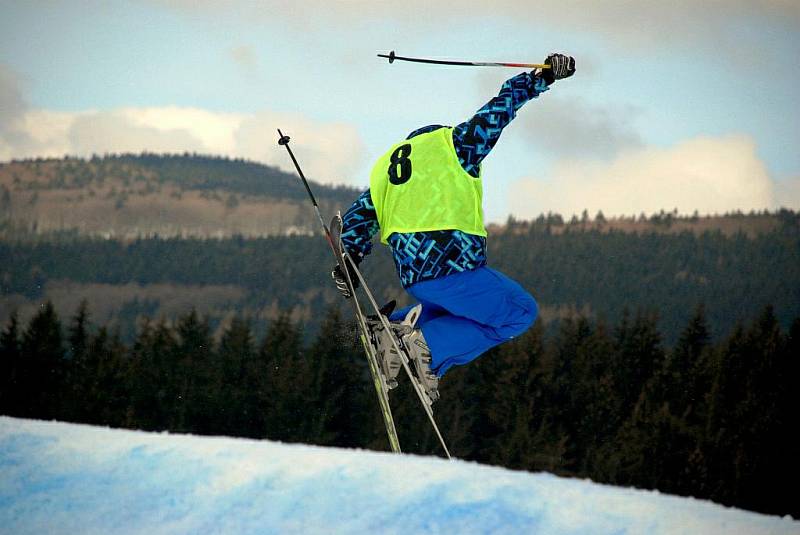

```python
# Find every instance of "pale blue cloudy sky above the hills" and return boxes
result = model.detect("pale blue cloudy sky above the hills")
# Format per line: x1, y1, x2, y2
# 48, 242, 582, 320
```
0, 0, 800, 222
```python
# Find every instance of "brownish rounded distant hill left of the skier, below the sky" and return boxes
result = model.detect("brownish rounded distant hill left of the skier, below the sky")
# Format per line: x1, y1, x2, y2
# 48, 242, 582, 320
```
0, 153, 358, 237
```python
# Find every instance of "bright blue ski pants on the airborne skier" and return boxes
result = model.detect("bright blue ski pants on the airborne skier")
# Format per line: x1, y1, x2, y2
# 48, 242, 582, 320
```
390, 266, 539, 377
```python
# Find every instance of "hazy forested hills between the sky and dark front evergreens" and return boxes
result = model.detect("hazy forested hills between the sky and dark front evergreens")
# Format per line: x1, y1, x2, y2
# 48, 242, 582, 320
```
0, 154, 800, 342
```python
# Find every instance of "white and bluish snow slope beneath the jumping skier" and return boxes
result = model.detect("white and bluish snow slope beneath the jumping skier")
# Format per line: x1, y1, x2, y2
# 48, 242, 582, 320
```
0, 417, 800, 535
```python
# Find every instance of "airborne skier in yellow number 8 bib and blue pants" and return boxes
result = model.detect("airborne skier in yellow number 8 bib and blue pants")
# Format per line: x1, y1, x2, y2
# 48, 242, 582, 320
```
331, 54, 575, 401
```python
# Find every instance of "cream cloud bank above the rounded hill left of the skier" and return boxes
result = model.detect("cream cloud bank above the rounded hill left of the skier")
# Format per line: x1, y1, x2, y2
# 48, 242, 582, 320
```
0, 103, 365, 184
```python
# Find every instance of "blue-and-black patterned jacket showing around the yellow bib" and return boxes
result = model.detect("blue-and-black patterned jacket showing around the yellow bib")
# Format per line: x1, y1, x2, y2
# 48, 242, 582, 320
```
342, 72, 547, 288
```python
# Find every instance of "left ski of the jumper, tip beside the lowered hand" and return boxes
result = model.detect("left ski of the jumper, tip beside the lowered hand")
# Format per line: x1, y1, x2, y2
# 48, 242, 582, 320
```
330, 215, 401, 453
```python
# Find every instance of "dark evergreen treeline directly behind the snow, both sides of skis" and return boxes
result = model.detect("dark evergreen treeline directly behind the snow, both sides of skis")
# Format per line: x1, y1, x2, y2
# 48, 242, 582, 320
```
0, 303, 800, 518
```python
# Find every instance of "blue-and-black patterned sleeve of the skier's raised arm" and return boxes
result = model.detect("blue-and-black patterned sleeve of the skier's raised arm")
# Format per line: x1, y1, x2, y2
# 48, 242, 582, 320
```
453, 72, 548, 177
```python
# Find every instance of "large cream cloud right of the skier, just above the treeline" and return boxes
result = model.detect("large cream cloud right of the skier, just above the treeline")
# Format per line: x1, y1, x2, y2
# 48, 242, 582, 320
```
510, 135, 780, 218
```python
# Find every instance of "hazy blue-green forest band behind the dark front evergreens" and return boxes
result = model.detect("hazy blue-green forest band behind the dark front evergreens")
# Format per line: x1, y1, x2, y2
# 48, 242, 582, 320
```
0, 212, 800, 343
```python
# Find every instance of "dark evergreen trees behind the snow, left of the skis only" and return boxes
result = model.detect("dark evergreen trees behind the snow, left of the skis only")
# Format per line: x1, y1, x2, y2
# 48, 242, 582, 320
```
0, 302, 370, 447
